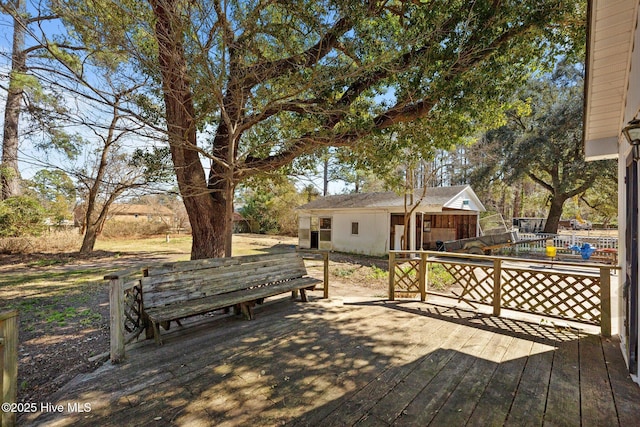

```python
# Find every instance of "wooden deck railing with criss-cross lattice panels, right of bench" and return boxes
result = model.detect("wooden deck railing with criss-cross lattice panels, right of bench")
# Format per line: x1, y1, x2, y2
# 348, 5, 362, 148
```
389, 251, 618, 336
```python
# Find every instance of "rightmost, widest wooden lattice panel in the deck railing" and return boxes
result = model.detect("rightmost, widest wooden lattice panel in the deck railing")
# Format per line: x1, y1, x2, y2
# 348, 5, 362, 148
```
502, 268, 601, 324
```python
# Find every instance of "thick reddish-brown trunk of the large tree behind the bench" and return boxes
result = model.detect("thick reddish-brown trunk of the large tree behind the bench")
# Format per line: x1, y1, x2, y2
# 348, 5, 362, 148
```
150, 0, 228, 259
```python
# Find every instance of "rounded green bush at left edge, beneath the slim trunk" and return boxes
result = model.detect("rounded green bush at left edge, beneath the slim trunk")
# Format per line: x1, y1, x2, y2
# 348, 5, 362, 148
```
0, 196, 45, 237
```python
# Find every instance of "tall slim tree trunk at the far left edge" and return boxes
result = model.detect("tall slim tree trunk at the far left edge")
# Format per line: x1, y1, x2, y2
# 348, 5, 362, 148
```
0, 0, 27, 200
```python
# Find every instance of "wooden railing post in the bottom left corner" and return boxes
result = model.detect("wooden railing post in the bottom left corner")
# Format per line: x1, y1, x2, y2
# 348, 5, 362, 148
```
0, 310, 18, 426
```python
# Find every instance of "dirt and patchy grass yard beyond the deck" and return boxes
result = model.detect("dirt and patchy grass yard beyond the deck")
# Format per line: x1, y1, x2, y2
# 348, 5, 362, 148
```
0, 236, 388, 403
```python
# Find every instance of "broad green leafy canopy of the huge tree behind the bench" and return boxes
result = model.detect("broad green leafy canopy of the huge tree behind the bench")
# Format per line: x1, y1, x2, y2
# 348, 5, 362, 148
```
57, 0, 585, 177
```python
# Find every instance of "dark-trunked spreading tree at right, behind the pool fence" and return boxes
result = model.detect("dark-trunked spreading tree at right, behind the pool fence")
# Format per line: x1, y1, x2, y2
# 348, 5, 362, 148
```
474, 61, 615, 233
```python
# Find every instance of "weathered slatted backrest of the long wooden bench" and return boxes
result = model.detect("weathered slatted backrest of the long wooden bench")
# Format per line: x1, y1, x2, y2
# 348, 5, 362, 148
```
142, 252, 307, 308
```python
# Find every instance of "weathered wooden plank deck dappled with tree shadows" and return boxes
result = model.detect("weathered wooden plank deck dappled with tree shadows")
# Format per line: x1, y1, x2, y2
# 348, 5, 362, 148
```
20, 298, 640, 427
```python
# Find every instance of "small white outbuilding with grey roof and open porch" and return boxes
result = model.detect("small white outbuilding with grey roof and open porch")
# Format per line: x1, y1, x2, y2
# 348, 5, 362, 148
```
298, 185, 485, 255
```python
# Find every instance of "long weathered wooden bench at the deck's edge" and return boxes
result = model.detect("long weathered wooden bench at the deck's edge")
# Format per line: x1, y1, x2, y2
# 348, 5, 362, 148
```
141, 253, 322, 344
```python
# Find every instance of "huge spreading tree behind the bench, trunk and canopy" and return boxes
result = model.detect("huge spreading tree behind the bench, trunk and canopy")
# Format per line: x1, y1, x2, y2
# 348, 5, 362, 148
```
56, 0, 584, 259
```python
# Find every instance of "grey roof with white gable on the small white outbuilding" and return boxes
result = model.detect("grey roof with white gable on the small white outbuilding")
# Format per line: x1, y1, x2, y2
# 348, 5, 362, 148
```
298, 185, 484, 211
